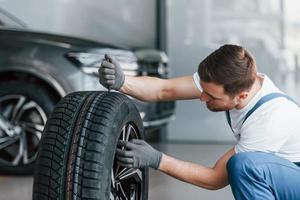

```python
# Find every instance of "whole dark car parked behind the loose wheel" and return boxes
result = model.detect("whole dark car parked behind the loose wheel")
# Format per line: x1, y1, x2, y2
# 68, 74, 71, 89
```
0, 15, 175, 174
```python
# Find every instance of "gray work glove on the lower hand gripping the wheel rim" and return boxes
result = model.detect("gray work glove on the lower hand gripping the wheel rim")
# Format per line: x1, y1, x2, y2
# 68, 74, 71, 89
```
116, 139, 162, 169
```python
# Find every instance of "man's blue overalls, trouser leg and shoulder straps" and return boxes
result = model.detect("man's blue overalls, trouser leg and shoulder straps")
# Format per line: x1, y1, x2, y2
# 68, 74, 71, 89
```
226, 93, 300, 200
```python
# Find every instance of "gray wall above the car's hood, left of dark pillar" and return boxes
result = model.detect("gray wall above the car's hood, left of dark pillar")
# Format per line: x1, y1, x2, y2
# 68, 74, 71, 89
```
0, 0, 156, 48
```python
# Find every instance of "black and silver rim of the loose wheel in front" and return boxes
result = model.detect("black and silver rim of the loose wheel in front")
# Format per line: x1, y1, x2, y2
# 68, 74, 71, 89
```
110, 123, 145, 200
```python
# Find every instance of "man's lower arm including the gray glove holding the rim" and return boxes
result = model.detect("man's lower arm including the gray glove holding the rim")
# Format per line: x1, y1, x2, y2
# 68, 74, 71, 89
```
116, 139, 235, 190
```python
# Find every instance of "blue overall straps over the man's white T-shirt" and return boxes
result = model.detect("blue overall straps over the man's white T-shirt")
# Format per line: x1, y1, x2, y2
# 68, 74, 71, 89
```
226, 93, 299, 132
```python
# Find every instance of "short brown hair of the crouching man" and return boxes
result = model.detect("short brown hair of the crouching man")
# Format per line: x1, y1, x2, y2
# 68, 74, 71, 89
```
198, 44, 256, 96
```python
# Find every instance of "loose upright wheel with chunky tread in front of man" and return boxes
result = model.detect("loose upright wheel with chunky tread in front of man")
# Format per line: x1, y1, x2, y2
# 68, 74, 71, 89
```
33, 92, 148, 200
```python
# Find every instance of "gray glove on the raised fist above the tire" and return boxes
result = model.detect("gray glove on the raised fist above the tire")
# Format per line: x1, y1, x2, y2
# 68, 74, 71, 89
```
98, 54, 125, 90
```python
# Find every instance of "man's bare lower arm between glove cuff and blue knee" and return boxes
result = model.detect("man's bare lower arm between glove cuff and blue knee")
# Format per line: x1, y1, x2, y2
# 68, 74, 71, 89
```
158, 148, 235, 190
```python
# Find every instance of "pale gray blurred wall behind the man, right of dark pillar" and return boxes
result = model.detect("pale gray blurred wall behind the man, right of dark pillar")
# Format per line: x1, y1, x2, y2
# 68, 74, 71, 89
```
167, 0, 300, 142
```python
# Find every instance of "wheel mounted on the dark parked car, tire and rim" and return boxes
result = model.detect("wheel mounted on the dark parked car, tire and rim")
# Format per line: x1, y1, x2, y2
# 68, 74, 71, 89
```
0, 81, 55, 175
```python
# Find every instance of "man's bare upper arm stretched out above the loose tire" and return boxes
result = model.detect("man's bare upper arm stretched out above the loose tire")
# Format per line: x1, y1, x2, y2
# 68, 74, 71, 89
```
120, 76, 201, 101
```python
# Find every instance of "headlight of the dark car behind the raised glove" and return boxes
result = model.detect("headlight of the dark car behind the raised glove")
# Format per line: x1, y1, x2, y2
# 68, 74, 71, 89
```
66, 49, 138, 76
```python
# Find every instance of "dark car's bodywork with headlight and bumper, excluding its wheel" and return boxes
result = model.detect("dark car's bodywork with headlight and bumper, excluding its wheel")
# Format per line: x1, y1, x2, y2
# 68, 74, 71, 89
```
0, 29, 174, 128
